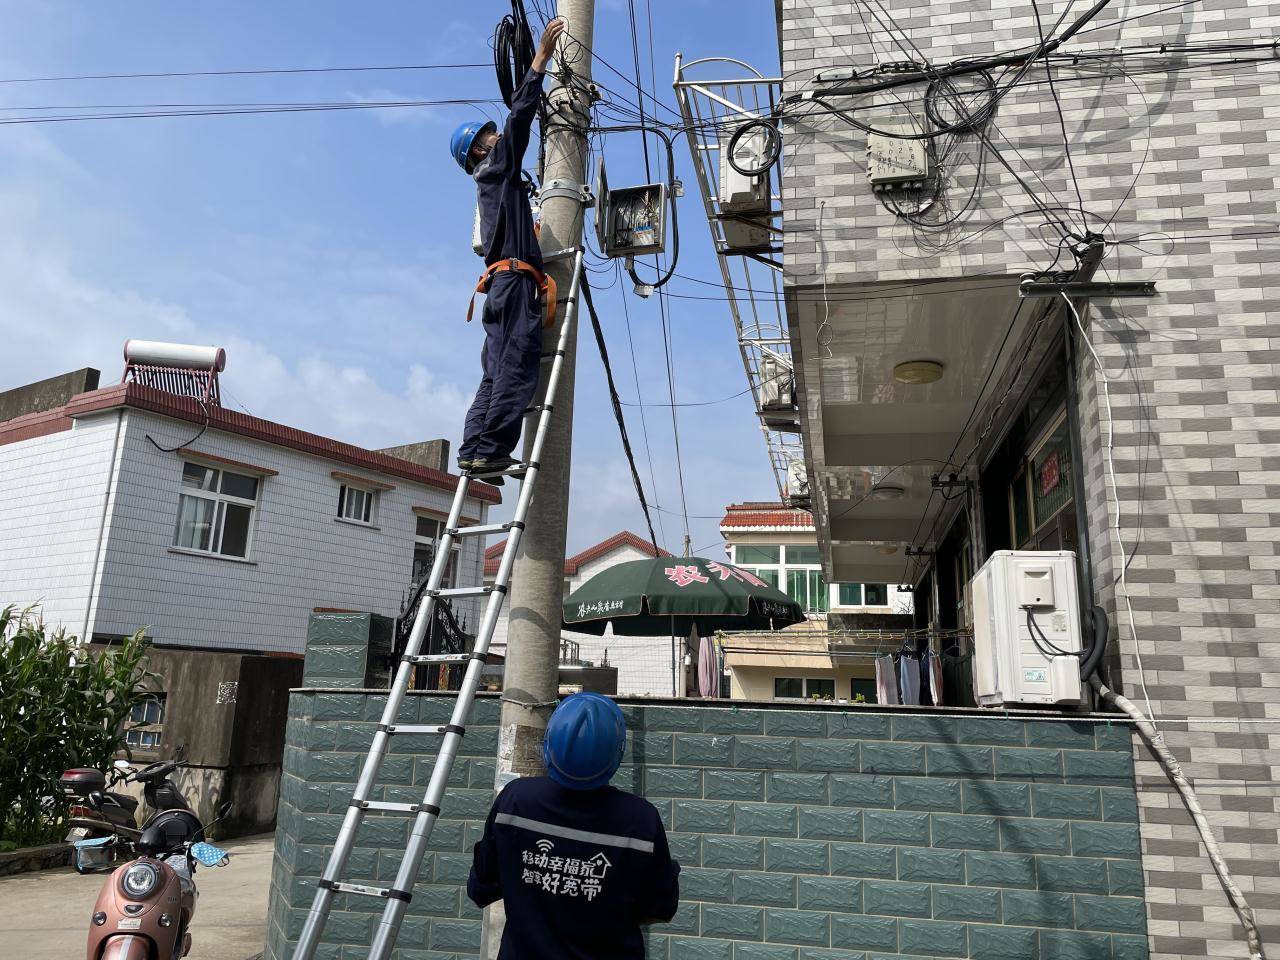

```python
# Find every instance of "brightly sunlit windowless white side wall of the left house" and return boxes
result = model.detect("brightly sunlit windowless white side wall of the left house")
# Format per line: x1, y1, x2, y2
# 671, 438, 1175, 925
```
0, 412, 124, 636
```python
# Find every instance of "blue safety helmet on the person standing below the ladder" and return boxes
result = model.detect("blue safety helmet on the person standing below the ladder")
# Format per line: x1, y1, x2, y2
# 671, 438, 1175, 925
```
543, 694, 627, 790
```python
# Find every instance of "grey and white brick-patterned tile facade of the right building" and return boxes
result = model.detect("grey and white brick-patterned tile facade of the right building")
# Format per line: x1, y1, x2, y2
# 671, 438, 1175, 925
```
778, 0, 1280, 960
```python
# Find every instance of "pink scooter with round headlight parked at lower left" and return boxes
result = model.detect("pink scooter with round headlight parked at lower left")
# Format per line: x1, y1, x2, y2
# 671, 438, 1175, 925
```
76, 760, 230, 960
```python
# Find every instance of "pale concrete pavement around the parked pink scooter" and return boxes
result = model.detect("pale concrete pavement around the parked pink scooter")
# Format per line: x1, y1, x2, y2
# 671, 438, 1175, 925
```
0, 833, 271, 960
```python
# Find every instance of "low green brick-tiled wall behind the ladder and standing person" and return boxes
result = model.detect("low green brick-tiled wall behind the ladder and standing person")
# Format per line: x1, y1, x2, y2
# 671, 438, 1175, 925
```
266, 690, 1147, 960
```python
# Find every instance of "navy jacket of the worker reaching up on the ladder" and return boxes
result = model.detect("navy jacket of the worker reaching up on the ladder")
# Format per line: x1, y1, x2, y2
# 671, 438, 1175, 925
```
474, 70, 543, 270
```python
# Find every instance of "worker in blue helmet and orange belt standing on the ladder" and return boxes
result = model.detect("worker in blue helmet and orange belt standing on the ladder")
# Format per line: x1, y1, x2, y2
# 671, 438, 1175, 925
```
449, 18, 564, 484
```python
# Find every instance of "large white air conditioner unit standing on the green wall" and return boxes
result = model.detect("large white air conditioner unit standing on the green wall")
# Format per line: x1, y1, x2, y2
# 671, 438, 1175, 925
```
969, 550, 1082, 707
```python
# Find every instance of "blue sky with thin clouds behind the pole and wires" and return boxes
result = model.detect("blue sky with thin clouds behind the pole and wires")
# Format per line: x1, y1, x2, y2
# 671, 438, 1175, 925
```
0, 0, 777, 556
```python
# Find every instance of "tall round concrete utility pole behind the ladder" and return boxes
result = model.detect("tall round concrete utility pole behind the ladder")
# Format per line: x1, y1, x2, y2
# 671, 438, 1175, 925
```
481, 0, 595, 957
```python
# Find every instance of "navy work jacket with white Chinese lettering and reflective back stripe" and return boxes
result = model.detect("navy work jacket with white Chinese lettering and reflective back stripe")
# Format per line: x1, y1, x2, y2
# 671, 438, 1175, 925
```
467, 777, 680, 960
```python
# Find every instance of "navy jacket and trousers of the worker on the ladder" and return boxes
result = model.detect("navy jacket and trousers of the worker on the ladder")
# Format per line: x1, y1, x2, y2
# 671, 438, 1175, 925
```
458, 70, 543, 460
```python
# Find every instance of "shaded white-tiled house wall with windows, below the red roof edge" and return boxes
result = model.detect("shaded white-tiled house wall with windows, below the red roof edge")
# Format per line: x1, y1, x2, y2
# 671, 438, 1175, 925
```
86, 411, 486, 653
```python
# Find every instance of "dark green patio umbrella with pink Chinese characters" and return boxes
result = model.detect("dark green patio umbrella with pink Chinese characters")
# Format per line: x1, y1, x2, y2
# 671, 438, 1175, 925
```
563, 557, 805, 636
